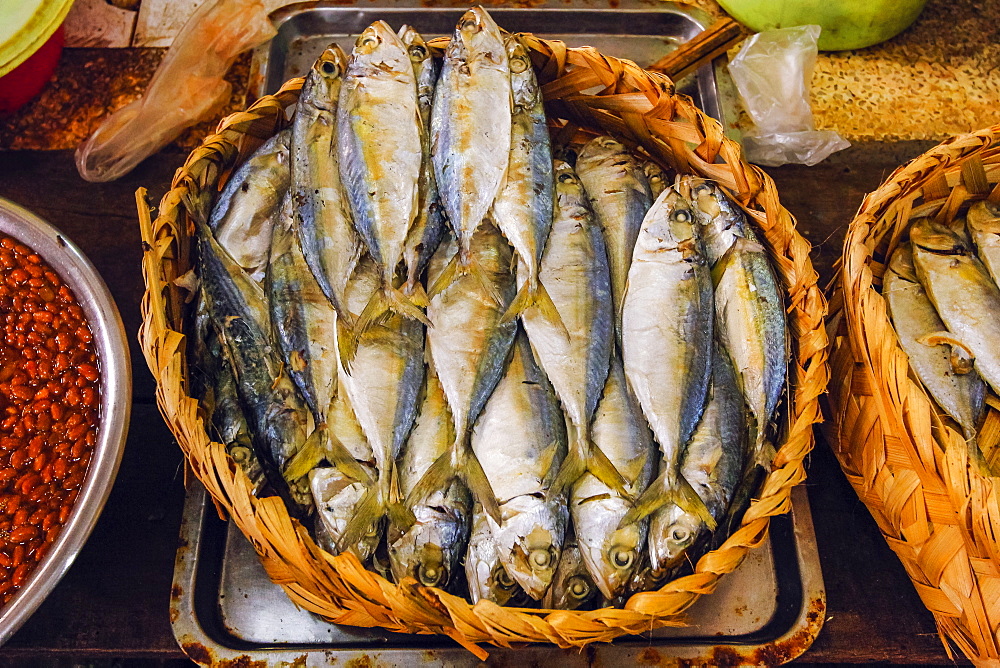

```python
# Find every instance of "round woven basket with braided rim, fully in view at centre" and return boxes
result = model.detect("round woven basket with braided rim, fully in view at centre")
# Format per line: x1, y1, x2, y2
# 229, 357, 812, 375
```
137, 35, 828, 658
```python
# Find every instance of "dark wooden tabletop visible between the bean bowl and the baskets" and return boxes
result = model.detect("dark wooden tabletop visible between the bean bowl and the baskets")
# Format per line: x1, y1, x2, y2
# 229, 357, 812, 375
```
0, 143, 968, 665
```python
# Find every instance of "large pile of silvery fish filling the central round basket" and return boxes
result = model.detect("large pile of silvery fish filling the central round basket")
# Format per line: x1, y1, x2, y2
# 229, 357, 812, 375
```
191, 8, 788, 608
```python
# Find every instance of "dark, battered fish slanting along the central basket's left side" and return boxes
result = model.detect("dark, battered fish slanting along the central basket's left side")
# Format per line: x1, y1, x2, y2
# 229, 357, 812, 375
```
198, 223, 314, 512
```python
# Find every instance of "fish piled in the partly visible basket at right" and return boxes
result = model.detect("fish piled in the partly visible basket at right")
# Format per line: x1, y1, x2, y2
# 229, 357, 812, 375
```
882, 201, 1000, 475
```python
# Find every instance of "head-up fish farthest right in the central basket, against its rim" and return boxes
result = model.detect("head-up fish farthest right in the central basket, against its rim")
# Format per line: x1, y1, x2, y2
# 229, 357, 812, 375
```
682, 177, 788, 468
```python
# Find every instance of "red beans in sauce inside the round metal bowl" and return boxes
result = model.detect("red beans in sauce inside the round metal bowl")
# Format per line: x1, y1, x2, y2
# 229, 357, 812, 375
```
0, 235, 100, 603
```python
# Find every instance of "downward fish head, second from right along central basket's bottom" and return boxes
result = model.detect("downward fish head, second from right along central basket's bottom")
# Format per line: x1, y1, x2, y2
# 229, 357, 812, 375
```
573, 495, 647, 599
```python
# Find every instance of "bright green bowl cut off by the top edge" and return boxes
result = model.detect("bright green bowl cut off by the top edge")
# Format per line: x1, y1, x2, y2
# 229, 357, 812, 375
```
719, 0, 927, 51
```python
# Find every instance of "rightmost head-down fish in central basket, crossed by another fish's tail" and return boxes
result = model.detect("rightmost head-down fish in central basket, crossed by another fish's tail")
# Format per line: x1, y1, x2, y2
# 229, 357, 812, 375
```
649, 348, 750, 573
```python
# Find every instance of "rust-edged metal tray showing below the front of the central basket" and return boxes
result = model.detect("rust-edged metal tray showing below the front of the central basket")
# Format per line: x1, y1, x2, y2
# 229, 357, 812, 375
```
170, 482, 826, 667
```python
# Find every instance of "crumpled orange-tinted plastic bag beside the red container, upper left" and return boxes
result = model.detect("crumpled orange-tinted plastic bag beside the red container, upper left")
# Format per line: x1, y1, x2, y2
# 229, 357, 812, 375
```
76, 0, 275, 182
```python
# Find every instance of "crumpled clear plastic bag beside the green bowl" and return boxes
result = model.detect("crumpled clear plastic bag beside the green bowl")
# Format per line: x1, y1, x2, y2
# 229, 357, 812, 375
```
729, 26, 850, 166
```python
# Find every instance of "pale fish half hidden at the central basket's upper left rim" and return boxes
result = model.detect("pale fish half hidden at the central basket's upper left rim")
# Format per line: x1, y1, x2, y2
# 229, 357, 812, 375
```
208, 129, 291, 283
